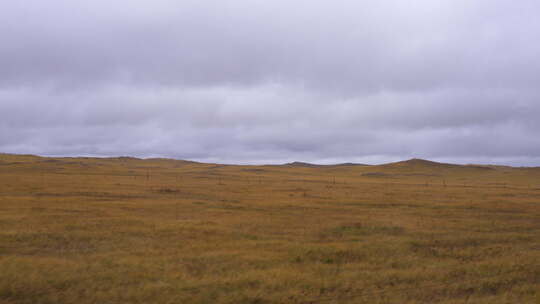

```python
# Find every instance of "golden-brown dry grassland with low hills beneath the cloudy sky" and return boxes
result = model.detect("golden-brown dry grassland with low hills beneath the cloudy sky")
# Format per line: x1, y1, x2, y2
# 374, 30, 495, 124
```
0, 154, 540, 304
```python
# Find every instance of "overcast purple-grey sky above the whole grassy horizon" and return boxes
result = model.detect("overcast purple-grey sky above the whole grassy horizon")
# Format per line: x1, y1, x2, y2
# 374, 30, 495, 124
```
0, 0, 540, 166
